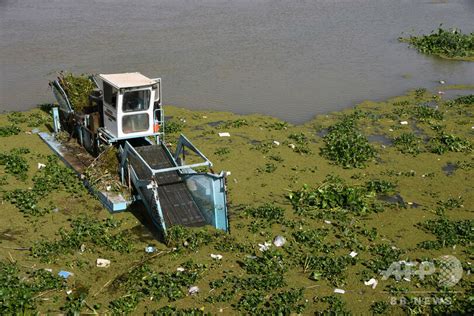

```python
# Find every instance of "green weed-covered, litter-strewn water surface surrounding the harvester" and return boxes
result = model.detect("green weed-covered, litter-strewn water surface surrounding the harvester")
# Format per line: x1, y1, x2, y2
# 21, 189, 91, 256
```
0, 89, 474, 314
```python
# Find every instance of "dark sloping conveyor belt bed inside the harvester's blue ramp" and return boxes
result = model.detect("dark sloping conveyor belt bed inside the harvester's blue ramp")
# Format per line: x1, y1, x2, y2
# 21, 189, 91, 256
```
133, 145, 207, 227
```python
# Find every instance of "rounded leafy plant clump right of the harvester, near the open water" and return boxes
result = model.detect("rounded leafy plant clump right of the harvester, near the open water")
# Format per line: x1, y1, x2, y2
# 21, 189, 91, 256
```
321, 115, 376, 168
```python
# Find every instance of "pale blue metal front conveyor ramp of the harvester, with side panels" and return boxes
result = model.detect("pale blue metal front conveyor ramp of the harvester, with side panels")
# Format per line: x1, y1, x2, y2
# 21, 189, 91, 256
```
121, 135, 228, 234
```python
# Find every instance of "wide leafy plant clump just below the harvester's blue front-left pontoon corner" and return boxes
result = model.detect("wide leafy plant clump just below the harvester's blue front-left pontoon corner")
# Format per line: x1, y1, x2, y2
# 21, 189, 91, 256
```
31, 216, 132, 262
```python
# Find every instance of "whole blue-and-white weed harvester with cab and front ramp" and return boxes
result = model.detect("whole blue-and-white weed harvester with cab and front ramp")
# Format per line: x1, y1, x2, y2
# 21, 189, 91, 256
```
40, 72, 228, 235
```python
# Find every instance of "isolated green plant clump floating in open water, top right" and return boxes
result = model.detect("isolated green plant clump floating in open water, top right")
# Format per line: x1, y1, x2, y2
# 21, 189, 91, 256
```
399, 26, 474, 60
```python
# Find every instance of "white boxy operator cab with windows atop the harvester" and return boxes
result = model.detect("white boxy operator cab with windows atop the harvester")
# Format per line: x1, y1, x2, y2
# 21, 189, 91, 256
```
97, 72, 161, 139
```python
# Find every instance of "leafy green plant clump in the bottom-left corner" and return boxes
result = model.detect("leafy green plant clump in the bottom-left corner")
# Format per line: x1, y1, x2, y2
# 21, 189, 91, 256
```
0, 261, 66, 315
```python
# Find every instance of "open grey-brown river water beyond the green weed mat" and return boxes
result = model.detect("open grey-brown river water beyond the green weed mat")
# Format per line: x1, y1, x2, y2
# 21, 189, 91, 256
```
0, 0, 474, 123
